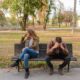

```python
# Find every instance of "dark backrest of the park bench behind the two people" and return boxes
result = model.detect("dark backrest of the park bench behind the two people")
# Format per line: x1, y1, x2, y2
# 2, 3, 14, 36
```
14, 43, 73, 58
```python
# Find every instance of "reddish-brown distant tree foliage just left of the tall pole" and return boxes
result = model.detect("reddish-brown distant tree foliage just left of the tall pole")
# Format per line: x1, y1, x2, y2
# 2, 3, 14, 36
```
53, 11, 74, 27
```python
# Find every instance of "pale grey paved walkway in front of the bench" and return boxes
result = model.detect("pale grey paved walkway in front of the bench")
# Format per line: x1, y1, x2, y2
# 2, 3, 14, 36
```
0, 68, 80, 80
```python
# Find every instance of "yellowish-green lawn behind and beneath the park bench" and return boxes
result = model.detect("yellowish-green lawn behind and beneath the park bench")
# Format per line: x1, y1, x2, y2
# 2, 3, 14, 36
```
0, 30, 80, 68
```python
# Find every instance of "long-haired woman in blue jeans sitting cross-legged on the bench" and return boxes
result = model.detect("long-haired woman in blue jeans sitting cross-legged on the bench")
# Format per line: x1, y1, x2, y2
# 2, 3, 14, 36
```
11, 29, 39, 78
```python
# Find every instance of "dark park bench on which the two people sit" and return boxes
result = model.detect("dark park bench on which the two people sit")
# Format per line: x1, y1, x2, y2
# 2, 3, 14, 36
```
12, 43, 77, 72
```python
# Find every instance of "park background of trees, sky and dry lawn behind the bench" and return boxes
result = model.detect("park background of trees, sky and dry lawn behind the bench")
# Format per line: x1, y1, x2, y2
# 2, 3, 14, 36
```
0, 0, 80, 68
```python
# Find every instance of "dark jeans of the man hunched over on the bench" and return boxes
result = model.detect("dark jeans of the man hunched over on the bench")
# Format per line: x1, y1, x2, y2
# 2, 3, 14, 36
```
45, 53, 71, 69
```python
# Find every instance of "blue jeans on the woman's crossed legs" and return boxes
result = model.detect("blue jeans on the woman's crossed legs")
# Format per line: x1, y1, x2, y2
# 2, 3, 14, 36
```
19, 48, 38, 68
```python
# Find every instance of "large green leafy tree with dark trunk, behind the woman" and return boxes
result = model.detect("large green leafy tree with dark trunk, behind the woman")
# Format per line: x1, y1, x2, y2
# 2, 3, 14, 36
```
2, 0, 44, 30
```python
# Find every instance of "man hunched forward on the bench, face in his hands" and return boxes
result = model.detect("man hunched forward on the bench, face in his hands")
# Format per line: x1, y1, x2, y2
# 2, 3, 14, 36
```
46, 37, 70, 75
